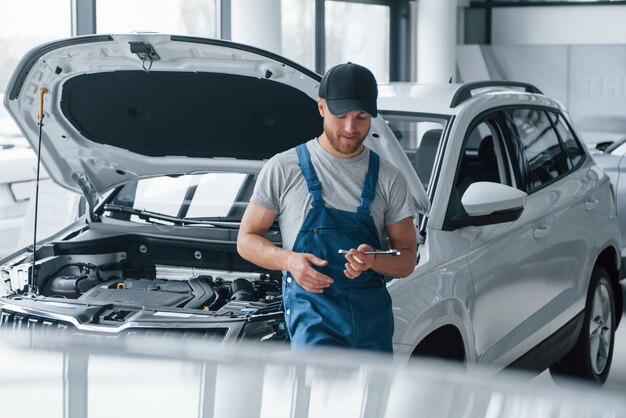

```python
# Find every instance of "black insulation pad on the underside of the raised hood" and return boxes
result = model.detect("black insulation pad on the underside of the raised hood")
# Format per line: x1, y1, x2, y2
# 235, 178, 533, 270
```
61, 70, 322, 160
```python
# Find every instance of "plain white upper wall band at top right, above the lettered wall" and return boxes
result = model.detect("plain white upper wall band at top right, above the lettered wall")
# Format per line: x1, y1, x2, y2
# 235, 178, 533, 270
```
492, 5, 626, 45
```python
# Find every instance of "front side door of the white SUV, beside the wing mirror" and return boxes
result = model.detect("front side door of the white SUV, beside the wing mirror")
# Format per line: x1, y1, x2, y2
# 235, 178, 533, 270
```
448, 112, 548, 365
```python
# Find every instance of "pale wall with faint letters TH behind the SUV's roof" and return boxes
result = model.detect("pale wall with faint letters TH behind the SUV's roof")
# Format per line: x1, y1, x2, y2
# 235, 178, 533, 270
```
457, 44, 626, 143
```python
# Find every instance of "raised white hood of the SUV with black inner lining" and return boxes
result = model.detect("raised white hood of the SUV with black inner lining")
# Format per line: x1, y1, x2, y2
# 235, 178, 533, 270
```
4, 34, 322, 201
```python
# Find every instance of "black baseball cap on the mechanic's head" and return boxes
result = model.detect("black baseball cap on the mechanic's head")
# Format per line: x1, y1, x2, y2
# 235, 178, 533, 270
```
319, 62, 378, 117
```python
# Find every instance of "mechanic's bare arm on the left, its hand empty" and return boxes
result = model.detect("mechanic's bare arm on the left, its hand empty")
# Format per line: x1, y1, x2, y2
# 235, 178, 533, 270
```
237, 203, 333, 293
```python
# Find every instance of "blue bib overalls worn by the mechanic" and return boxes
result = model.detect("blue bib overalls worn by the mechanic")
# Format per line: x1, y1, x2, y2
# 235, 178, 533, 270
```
283, 144, 393, 352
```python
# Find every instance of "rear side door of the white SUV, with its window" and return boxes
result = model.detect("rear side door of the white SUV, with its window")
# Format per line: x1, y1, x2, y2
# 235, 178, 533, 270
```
504, 108, 600, 360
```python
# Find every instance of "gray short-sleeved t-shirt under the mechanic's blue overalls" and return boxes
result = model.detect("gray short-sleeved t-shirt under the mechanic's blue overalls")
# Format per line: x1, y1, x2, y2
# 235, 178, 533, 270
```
250, 139, 415, 250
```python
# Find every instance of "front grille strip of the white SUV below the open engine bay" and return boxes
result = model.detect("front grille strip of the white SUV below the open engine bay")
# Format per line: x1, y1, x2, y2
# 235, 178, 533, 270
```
0, 309, 228, 340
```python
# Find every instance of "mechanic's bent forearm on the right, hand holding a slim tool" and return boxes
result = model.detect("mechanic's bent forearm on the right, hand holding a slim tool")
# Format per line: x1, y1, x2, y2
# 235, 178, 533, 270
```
344, 218, 417, 279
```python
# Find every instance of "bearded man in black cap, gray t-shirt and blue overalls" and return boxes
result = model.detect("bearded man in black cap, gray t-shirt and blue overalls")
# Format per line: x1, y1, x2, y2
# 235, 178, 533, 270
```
237, 63, 417, 352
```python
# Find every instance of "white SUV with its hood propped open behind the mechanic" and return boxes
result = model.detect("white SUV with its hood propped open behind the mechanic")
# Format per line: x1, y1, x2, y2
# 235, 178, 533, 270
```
0, 34, 622, 382
